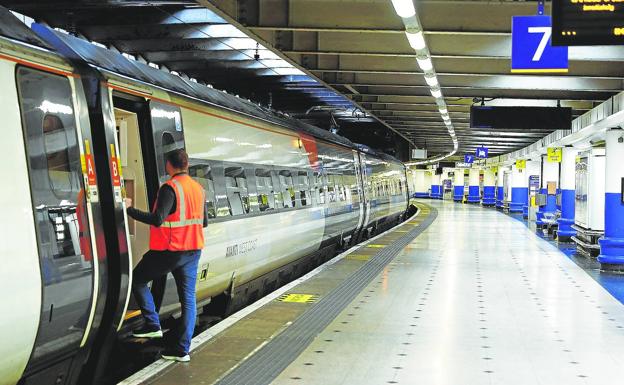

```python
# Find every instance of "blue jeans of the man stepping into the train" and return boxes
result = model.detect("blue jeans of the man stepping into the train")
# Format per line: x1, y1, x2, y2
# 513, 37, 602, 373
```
132, 250, 201, 353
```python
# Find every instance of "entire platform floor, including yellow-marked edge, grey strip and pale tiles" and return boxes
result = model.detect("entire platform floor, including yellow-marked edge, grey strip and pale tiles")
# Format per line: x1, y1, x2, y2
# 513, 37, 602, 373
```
122, 201, 624, 385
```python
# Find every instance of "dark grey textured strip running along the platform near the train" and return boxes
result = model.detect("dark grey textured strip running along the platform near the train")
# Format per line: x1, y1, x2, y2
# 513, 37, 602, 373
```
217, 207, 438, 385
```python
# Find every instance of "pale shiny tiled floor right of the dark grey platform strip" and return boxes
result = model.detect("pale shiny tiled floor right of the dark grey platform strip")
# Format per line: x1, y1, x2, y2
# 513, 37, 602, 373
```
274, 202, 624, 385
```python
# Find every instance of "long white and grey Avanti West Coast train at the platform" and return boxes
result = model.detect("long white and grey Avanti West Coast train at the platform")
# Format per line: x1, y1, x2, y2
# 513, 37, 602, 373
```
0, 9, 409, 385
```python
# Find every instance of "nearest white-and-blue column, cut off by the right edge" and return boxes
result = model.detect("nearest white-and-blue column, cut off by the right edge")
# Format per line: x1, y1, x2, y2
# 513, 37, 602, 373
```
598, 128, 624, 270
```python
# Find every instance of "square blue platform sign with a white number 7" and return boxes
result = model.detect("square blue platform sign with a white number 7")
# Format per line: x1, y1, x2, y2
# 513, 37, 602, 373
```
511, 16, 568, 73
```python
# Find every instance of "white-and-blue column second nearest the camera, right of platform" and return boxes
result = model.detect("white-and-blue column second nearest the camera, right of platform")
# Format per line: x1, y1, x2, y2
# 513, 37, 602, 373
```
557, 147, 578, 242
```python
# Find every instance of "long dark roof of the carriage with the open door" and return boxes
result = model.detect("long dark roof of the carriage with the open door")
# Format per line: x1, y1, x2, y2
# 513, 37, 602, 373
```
33, 23, 357, 149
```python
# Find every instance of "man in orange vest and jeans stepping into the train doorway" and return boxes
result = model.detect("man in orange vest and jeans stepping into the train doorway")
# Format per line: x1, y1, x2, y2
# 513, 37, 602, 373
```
126, 149, 207, 362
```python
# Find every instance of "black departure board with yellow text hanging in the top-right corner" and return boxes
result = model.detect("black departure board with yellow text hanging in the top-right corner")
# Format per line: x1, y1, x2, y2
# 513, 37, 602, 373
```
552, 0, 624, 46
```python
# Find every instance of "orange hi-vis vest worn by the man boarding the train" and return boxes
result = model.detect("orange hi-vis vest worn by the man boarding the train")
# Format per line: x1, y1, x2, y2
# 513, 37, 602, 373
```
150, 174, 204, 251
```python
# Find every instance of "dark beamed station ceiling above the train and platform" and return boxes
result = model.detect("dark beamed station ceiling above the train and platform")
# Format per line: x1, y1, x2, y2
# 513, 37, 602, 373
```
6, 0, 624, 159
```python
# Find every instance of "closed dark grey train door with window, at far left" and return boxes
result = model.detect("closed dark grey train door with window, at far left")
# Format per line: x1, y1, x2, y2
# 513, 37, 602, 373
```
16, 67, 93, 363
